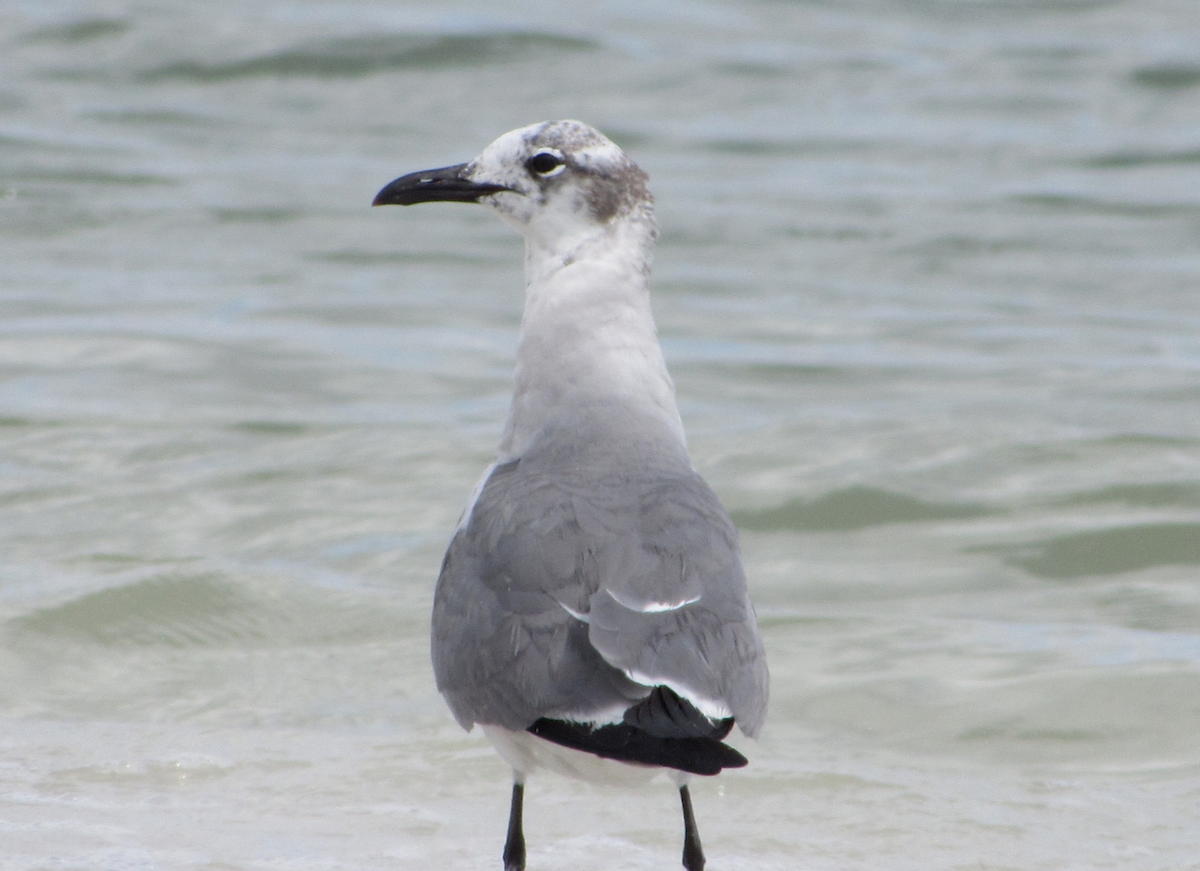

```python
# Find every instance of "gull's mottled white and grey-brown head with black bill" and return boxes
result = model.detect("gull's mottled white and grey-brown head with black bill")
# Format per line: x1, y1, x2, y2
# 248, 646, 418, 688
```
374, 121, 654, 250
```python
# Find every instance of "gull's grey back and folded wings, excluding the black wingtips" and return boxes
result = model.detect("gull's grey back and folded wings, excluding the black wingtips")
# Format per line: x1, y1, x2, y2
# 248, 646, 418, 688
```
433, 461, 767, 735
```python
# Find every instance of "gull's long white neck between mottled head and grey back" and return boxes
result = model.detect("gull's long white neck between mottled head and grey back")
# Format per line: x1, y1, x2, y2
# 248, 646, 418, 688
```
500, 223, 686, 463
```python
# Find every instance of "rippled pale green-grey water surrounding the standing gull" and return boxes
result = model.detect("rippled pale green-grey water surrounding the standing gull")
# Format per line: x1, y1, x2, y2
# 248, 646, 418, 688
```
0, 0, 1200, 871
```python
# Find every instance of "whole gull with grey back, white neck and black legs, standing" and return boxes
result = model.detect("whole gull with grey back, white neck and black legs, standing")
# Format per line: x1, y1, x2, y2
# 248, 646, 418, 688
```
374, 121, 767, 871
